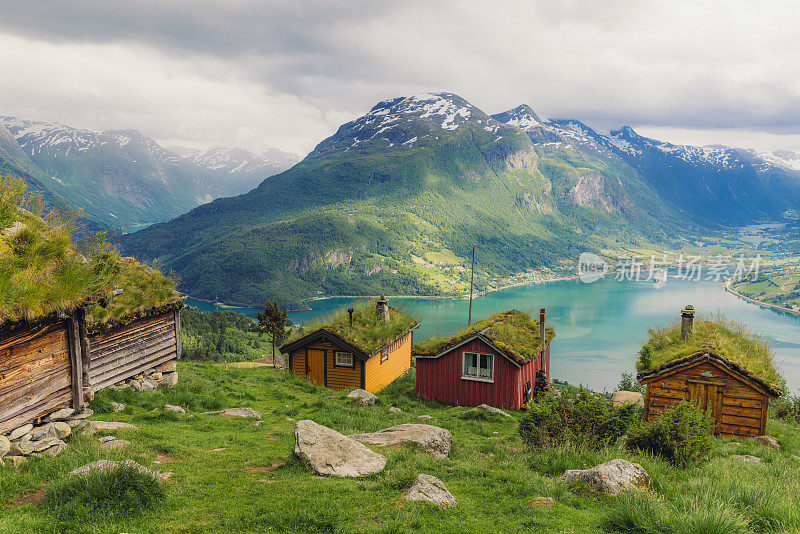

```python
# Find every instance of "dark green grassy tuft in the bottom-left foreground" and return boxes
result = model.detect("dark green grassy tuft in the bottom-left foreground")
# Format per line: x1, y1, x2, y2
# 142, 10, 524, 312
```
45, 465, 166, 521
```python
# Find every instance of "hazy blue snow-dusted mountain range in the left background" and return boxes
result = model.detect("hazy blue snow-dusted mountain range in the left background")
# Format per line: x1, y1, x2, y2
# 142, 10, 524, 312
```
0, 117, 296, 229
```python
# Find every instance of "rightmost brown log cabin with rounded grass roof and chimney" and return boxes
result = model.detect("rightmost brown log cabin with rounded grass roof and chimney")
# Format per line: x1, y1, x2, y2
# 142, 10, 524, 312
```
637, 306, 782, 437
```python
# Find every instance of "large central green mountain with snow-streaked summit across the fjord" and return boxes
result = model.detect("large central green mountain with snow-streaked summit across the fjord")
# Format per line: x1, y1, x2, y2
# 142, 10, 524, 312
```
122, 93, 674, 305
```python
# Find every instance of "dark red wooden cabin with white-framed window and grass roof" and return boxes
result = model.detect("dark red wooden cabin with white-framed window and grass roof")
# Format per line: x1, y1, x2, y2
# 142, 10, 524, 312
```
414, 310, 555, 410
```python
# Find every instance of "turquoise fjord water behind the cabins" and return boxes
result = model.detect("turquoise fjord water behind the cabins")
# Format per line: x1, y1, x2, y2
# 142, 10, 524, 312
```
187, 278, 800, 393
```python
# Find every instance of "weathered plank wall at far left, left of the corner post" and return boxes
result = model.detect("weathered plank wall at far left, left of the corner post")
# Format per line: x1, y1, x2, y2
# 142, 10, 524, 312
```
0, 321, 72, 438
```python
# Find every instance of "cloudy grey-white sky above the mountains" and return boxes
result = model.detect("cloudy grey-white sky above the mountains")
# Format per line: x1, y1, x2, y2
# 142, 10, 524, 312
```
0, 0, 800, 157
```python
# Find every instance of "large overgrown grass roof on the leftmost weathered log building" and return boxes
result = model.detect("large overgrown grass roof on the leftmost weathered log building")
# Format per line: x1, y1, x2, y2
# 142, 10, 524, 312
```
0, 176, 181, 326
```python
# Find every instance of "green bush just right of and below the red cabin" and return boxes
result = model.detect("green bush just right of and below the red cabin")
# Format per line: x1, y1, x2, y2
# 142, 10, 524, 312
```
519, 389, 641, 449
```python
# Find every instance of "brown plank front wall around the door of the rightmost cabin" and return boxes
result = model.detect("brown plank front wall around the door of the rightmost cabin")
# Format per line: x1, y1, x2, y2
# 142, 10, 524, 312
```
645, 362, 769, 437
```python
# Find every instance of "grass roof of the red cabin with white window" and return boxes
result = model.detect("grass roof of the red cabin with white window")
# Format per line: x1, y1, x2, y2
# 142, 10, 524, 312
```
414, 310, 556, 363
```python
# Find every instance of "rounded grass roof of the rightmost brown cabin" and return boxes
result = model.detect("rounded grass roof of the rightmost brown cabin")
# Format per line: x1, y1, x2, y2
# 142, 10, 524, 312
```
636, 314, 784, 388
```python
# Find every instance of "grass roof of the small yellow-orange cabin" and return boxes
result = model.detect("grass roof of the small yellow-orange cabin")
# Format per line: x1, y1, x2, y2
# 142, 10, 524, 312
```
287, 300, 419, 355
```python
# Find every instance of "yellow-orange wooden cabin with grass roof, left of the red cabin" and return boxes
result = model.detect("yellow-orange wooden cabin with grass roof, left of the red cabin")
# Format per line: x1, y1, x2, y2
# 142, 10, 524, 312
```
281, 297, 419, 393
